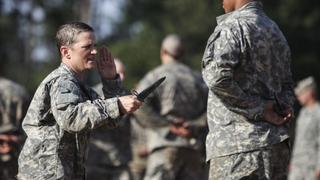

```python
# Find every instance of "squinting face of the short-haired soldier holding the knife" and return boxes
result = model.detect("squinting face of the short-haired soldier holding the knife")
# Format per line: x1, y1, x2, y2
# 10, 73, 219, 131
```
69, 32, 97, 73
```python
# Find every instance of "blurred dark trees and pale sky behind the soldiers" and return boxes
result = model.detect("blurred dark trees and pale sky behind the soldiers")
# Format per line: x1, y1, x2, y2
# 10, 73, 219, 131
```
0, 0, 320, 94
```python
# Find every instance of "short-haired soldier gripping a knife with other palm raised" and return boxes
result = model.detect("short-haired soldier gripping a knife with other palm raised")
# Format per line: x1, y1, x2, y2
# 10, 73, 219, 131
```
18, 22, 142, 180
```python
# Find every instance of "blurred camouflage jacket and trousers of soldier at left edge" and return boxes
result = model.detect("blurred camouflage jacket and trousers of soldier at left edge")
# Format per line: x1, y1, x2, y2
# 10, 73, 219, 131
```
0, 77, 28, 180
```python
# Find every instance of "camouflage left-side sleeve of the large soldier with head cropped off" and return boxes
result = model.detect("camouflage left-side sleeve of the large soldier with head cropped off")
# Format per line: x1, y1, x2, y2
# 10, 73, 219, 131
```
202, 28, 264, 119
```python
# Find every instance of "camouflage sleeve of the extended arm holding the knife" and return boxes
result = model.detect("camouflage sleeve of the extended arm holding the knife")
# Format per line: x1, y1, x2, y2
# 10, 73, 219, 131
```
50, 79, 119, 133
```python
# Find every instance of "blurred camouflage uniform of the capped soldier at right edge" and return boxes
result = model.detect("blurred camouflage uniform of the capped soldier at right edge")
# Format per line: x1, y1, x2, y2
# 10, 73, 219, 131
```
289, 103, 320, 180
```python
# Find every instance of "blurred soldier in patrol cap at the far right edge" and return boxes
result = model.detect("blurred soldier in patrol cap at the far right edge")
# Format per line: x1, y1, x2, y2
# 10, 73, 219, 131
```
289, 77, 320, 180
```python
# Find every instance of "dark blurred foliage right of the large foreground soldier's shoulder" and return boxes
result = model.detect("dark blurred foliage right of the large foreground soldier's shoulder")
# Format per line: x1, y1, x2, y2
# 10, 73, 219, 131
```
265, 0, 320, 81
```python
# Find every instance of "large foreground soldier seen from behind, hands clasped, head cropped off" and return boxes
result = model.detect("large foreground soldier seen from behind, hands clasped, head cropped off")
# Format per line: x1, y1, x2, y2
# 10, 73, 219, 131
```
202, 0, 294, 180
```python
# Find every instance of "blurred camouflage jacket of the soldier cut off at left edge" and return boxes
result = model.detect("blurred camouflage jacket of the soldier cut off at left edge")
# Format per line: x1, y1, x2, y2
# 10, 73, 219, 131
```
0, 77, 28, 134
